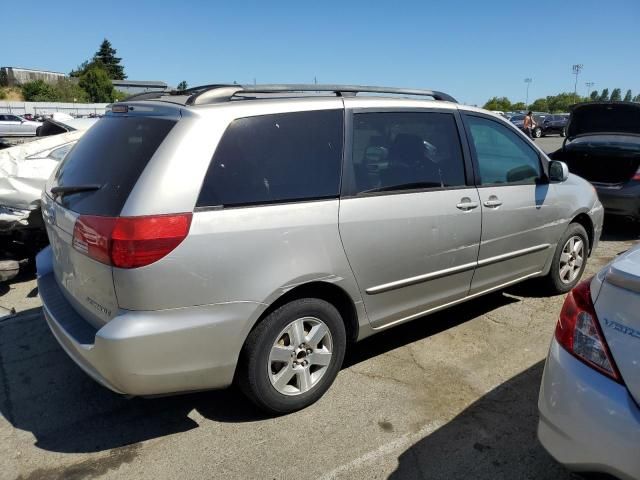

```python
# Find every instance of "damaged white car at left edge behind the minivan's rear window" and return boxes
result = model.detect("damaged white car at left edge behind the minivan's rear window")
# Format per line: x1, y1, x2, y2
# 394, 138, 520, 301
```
0, 115, 97, 281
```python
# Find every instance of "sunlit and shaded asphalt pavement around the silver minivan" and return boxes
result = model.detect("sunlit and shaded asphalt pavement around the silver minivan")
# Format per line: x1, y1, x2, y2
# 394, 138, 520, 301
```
0, 131, 639, 480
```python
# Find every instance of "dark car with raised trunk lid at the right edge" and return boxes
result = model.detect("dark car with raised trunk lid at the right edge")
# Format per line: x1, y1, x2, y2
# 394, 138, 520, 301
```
550, 102, 640, 220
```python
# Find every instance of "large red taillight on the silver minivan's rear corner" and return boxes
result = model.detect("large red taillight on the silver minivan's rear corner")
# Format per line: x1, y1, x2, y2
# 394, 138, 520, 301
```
73, 213, 192, 268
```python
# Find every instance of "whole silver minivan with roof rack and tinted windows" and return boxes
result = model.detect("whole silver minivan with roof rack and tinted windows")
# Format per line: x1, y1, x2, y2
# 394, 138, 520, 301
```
38, 85, 603, 413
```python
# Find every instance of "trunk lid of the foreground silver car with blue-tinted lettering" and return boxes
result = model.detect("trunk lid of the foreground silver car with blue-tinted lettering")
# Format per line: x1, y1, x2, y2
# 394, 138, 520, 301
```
595, 247, 640, 403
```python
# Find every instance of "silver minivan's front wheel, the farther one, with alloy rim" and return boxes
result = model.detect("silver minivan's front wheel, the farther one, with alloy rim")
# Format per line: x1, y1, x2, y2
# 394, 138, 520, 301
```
545, 223, 589, 294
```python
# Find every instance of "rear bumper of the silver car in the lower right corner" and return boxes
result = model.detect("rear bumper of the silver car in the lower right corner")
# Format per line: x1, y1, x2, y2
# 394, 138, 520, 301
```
538, 338, 640, 480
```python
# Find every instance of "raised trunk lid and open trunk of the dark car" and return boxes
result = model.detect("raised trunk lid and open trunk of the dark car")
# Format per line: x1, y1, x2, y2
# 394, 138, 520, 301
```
552, 102, 640, 186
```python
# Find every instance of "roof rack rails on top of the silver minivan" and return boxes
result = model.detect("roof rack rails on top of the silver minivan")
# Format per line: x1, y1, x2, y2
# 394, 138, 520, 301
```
116, 83, 457, 105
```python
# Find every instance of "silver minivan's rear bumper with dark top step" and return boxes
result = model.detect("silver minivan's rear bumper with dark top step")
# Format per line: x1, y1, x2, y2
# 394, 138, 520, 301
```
38, 249, 260, 395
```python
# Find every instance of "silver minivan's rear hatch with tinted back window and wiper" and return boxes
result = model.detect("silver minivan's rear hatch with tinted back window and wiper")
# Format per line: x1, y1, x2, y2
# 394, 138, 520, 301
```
42, 114, 176, 328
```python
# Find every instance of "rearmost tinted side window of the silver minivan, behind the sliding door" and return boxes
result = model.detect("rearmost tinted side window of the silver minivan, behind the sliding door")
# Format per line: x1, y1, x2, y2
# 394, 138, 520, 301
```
197, 110, 344, 207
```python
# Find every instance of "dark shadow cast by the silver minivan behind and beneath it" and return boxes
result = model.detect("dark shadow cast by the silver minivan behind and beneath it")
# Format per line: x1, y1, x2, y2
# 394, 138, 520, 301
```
0, 294, 517, 453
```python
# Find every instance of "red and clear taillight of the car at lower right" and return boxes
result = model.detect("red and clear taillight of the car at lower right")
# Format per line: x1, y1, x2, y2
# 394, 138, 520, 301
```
555, 279, 622, 382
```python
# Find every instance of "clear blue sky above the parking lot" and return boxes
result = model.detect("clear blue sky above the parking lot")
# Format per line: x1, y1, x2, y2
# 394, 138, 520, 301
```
0, 0, 640, 104
